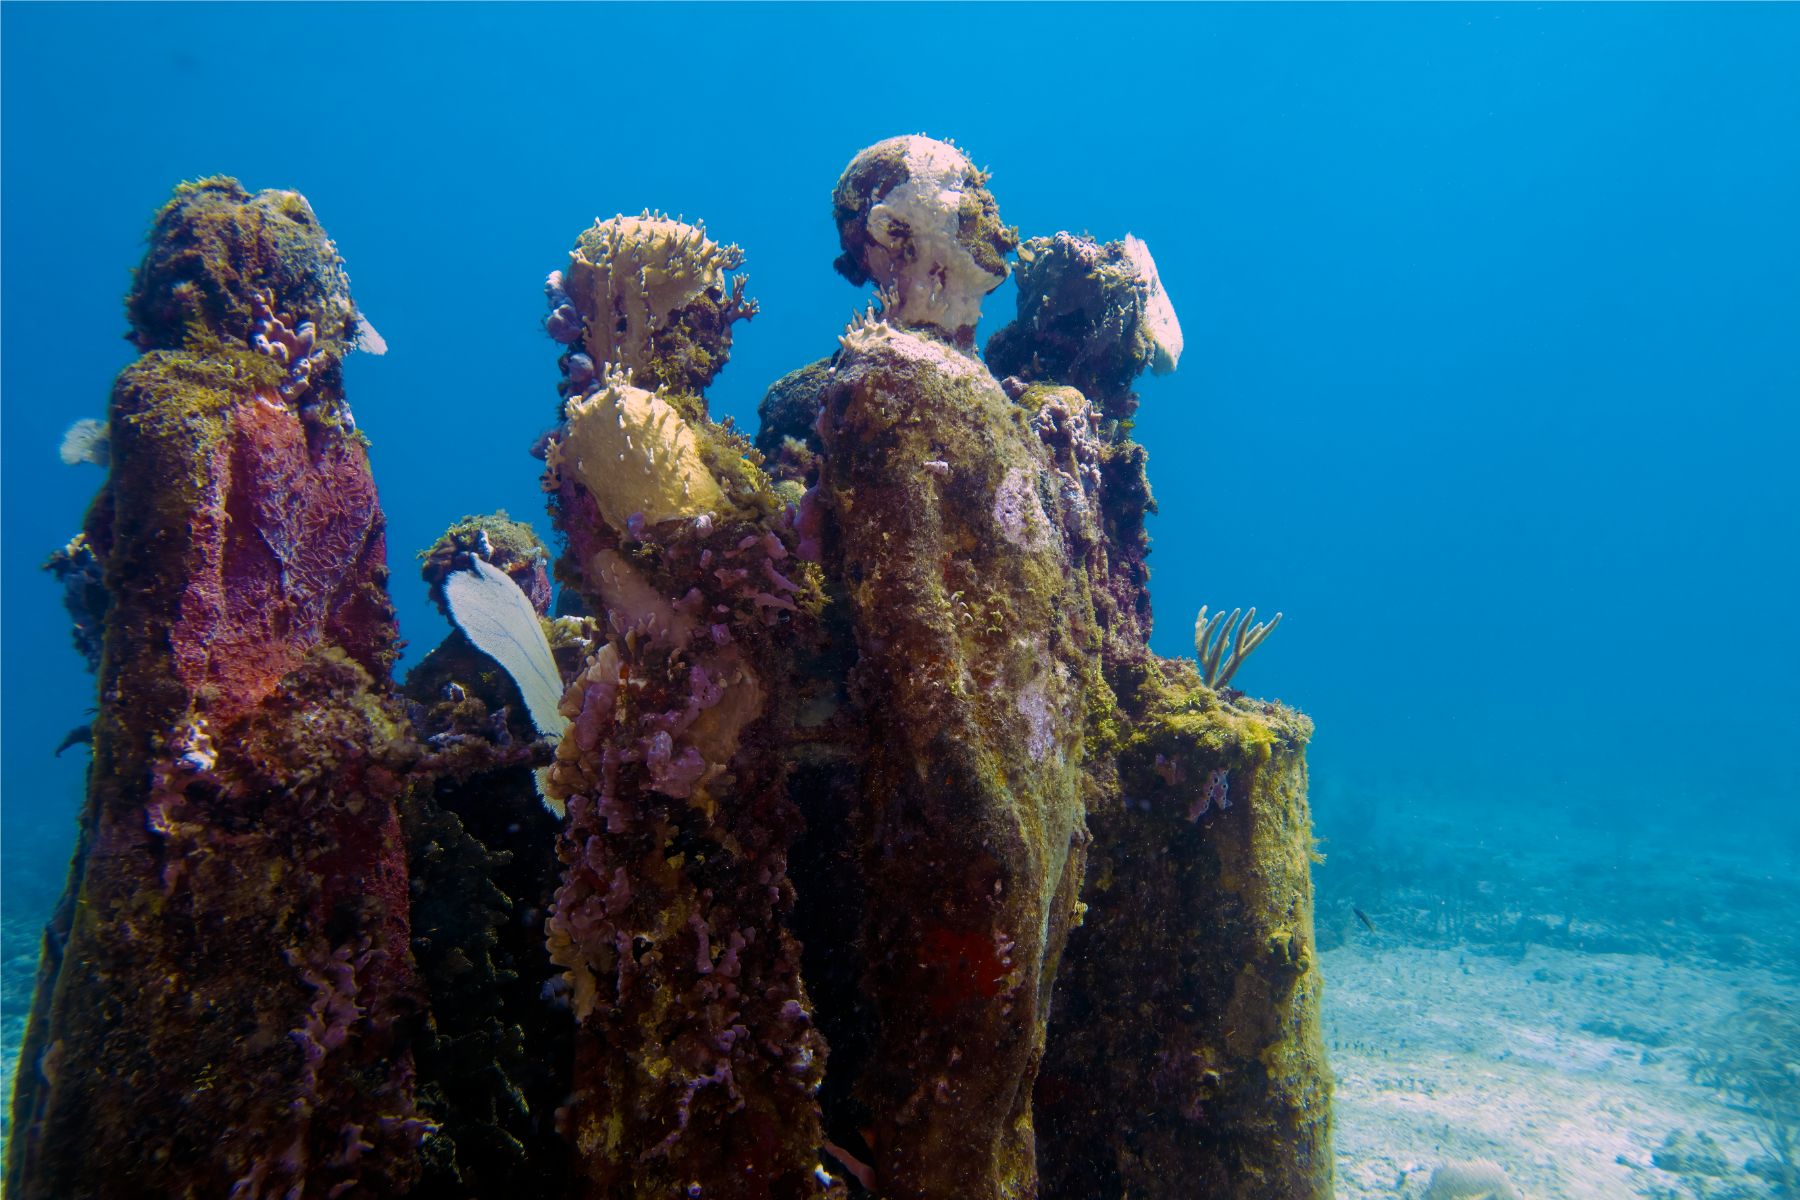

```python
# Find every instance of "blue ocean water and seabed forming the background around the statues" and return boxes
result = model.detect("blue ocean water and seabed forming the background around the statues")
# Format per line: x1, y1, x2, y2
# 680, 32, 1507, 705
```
0, 2, 1800, 1196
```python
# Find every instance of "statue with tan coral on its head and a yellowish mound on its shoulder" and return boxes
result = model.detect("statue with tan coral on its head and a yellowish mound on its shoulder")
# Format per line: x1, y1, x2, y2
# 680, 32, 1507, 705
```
547, 214, 841, 1200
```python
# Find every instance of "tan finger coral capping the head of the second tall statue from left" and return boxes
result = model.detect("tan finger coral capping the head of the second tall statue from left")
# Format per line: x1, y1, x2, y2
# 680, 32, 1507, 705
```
567, 209, 743, 374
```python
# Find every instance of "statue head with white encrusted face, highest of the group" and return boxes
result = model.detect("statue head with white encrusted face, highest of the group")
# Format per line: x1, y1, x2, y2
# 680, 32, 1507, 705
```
832, 135, 1019, 345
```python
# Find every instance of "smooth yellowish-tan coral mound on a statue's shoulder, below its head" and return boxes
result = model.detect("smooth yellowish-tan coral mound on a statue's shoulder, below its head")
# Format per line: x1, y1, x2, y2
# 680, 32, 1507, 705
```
549, 361, 727, 533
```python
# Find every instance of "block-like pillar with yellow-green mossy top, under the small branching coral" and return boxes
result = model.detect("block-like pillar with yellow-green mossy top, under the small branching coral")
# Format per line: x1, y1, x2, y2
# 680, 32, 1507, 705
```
1037, 662, 1332, 1200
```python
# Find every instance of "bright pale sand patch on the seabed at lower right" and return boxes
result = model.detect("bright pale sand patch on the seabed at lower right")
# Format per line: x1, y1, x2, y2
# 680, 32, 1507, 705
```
1321, 936, 1778, 1200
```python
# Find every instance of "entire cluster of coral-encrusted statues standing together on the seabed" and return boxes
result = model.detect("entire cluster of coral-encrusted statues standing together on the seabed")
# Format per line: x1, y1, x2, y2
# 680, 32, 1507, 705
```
7, 137, 1332, 1200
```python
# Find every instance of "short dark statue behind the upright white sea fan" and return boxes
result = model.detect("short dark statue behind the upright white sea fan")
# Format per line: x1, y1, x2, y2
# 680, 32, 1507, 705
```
400, 513, 568, 1200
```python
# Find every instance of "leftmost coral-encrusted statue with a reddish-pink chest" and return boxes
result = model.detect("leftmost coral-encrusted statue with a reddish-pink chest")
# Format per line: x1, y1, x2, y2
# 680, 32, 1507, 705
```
7, 178, 423, 1200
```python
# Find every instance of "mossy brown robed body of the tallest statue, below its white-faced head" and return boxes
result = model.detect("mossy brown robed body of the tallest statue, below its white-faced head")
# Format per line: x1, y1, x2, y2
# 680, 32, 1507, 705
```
821, 322, 1111, 1198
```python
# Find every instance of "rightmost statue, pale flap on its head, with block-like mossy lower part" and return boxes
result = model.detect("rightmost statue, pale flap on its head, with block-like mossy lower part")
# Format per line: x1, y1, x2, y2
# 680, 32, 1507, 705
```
988, 234, 1332, 1200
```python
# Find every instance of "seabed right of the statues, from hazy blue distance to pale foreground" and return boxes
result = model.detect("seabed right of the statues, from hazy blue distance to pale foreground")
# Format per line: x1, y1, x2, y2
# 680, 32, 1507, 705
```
1314, 799, 1800, 1200
